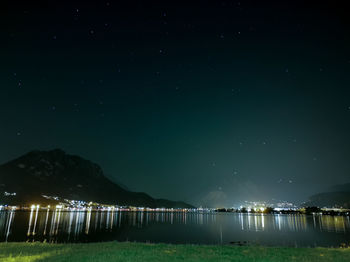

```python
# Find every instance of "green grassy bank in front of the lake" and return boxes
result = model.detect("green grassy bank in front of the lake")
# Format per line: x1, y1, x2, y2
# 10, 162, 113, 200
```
0, 242, 350, 262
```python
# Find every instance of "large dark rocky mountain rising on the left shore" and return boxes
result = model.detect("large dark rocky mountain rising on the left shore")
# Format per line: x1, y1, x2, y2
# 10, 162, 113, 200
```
0, 149, 192, 208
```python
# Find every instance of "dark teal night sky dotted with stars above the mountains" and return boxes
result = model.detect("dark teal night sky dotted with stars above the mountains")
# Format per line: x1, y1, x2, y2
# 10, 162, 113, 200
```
0, 0, 350, 205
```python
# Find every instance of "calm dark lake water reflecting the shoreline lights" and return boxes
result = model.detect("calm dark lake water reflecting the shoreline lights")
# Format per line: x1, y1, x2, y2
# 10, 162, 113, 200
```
0, 210, 350, 247
